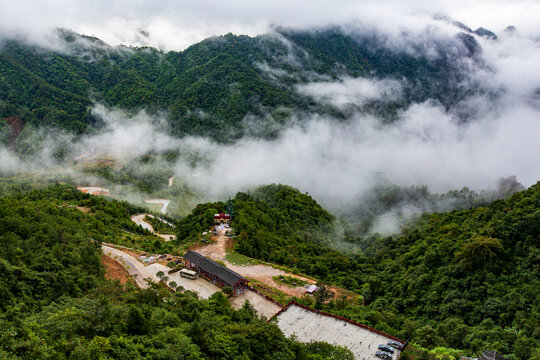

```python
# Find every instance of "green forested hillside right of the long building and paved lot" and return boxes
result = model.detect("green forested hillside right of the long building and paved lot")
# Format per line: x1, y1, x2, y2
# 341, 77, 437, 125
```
178, 184, 540, 359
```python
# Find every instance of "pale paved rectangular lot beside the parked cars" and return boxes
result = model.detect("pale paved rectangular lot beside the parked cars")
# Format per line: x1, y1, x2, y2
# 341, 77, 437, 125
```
277, 304, 399, 360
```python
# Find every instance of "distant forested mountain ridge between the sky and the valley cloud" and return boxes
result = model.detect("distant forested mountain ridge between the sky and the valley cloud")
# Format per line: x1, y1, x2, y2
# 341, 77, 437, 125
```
0, 23, 490, 141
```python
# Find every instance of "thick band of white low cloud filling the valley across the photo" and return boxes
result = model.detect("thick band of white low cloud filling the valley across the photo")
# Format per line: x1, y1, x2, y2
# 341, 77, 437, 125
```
0, 90, 540, 232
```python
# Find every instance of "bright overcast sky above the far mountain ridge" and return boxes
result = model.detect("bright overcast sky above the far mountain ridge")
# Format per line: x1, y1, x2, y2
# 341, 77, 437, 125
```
0, 0, 540, 50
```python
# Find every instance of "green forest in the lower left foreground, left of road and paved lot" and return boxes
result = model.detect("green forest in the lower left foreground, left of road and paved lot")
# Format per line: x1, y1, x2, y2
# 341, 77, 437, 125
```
0, 182, 352, 360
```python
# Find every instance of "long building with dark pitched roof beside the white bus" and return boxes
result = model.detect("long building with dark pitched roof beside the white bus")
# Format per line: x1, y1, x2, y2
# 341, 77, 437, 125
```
184, 250, 248, 294
